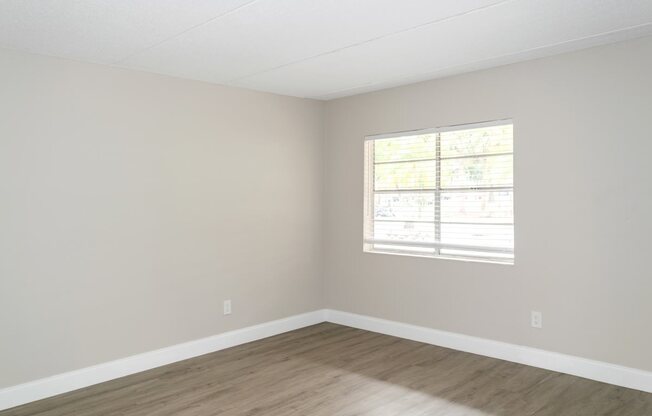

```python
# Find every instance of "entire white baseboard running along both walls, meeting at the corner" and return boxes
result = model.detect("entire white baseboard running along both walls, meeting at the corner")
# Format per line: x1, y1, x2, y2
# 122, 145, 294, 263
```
0, 309, 652, 410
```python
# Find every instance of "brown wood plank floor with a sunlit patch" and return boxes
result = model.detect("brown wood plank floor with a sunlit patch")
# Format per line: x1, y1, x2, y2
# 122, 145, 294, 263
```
0, 323, 652, 416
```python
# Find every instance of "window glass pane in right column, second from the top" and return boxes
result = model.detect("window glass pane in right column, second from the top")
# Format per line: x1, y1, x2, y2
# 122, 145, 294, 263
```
441, 155, 514, 188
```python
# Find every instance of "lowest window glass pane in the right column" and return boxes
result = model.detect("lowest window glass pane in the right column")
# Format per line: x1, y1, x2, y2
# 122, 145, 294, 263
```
441, 224, 514, 248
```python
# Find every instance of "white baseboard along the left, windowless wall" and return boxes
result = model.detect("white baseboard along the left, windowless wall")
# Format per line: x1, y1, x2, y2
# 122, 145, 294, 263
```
0, 310, 325, 410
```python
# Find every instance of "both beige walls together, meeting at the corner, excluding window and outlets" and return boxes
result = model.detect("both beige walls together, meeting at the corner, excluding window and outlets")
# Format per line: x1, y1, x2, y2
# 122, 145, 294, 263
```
0, 34, 652, 388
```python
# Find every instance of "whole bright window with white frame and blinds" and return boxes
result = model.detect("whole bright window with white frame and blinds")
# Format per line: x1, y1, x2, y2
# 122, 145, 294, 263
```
363, 120, 514, 263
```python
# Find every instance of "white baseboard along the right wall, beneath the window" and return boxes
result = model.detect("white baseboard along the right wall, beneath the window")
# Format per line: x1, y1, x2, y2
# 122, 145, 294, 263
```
326, 310, 652, 393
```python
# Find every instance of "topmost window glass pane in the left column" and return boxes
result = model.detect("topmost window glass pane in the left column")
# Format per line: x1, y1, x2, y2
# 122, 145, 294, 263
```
374, 134, 437, 163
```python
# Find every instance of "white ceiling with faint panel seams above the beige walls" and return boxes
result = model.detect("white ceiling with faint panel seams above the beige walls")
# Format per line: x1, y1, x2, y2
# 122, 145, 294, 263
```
0, 0, 652, 99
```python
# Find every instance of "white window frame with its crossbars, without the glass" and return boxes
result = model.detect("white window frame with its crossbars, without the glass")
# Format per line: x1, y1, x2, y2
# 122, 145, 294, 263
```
363, 119, 516, 265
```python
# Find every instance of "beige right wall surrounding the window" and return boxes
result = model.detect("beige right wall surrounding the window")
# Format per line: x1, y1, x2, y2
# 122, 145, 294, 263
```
324, 38, 652, 370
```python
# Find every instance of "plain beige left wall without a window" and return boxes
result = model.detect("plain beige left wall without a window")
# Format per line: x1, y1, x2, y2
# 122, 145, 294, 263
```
0, 52, 323, 387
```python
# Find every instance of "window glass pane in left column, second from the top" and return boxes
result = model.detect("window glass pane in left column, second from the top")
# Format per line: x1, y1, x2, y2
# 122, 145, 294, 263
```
374, 160, 437, 191
